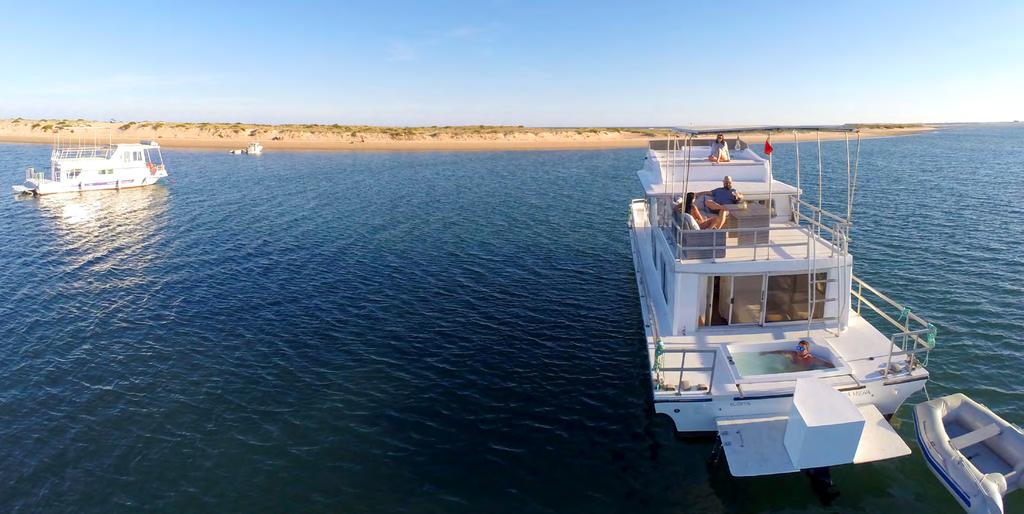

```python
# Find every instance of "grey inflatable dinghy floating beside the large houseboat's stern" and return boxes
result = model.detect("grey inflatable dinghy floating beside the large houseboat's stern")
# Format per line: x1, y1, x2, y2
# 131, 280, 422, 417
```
913, 393, 1024, 514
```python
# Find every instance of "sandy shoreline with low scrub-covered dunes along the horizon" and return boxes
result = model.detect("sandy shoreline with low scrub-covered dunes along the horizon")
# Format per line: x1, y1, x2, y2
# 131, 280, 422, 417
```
0, 119, 935, 152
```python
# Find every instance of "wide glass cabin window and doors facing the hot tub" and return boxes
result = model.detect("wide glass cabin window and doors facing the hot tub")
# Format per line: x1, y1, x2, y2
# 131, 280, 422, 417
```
698, 272, 827, 326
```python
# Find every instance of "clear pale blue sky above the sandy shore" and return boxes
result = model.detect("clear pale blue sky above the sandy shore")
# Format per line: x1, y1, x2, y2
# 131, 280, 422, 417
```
0, 0, 1024, 126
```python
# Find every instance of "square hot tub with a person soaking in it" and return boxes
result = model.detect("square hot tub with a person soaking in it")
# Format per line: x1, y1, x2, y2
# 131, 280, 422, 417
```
722, 338, 851, 384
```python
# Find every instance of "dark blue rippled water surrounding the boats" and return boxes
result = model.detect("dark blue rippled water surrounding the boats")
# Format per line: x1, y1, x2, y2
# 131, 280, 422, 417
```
0, 126, 1024, 513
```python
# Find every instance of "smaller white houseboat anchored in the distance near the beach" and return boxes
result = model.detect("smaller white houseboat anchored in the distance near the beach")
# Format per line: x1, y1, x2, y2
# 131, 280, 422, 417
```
13, 134, 167, 195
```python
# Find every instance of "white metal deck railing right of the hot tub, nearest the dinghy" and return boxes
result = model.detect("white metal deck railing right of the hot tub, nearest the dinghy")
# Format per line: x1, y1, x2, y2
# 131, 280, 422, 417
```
850, 276, 937, 381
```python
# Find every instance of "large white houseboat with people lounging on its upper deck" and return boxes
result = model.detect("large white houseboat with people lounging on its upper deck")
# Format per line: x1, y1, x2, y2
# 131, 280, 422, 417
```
629, 126, 935, 476
